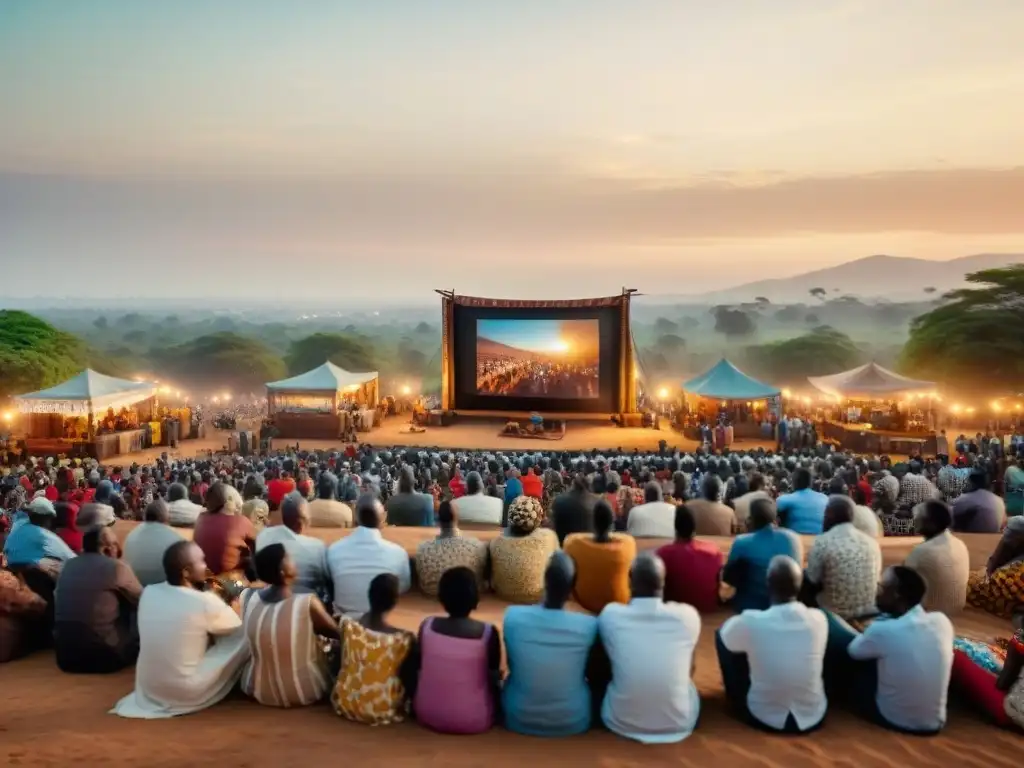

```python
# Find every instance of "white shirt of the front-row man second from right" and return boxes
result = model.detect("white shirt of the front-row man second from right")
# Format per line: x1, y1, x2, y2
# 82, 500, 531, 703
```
721, 602, 828, 730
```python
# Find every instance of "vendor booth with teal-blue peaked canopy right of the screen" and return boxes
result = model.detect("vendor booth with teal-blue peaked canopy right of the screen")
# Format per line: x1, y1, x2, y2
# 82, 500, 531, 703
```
682, 357, 781, 447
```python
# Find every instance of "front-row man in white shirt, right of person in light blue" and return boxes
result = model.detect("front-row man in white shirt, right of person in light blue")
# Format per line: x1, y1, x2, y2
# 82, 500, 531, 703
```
598, 552, 700, 743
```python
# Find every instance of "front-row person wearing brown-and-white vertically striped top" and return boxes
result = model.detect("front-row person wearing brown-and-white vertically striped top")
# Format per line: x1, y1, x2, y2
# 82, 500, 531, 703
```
241, 544, 338, 707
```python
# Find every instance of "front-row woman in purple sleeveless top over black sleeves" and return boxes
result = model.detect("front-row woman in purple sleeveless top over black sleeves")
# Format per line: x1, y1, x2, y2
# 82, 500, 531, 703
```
414, 569, 499, 734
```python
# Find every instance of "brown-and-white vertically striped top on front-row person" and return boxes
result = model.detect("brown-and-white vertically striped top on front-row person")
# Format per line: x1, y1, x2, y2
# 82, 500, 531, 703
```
242, 589, 330, 707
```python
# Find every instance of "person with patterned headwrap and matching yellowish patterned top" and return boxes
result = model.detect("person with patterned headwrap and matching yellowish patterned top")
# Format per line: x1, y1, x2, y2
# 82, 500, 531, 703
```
489, 496, 561, 604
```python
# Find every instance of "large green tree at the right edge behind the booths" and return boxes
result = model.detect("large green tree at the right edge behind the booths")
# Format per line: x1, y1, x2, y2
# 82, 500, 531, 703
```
900, 264, 1024, 391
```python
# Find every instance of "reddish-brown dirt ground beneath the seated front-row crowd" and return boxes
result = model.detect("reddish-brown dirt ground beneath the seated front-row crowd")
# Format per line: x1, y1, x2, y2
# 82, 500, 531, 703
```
0, 523, 1024, 768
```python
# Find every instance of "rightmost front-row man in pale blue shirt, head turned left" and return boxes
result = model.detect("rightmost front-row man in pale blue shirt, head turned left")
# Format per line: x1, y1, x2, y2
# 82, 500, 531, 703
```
825, 565, 953, 735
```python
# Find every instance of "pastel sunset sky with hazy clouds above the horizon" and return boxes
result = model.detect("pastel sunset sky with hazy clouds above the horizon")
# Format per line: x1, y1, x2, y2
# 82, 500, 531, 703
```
0, 0, 1024, 301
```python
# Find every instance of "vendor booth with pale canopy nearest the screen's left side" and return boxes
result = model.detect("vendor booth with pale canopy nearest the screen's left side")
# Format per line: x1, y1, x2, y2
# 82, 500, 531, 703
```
266, 362, 380, 439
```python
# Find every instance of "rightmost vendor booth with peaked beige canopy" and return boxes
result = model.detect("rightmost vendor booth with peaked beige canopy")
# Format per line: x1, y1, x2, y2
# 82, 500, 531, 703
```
808, 362, 937, 455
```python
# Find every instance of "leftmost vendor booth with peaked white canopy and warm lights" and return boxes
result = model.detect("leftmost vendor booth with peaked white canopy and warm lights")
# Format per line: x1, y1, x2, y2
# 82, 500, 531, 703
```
14, 370, 161, 461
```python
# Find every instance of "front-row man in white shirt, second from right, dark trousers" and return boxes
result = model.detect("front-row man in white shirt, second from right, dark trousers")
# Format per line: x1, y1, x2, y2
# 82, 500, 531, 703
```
715, 555, 828, 733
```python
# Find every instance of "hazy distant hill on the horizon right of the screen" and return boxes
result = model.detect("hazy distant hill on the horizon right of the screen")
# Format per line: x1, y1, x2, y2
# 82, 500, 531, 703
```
651, 253, 1024, 304
